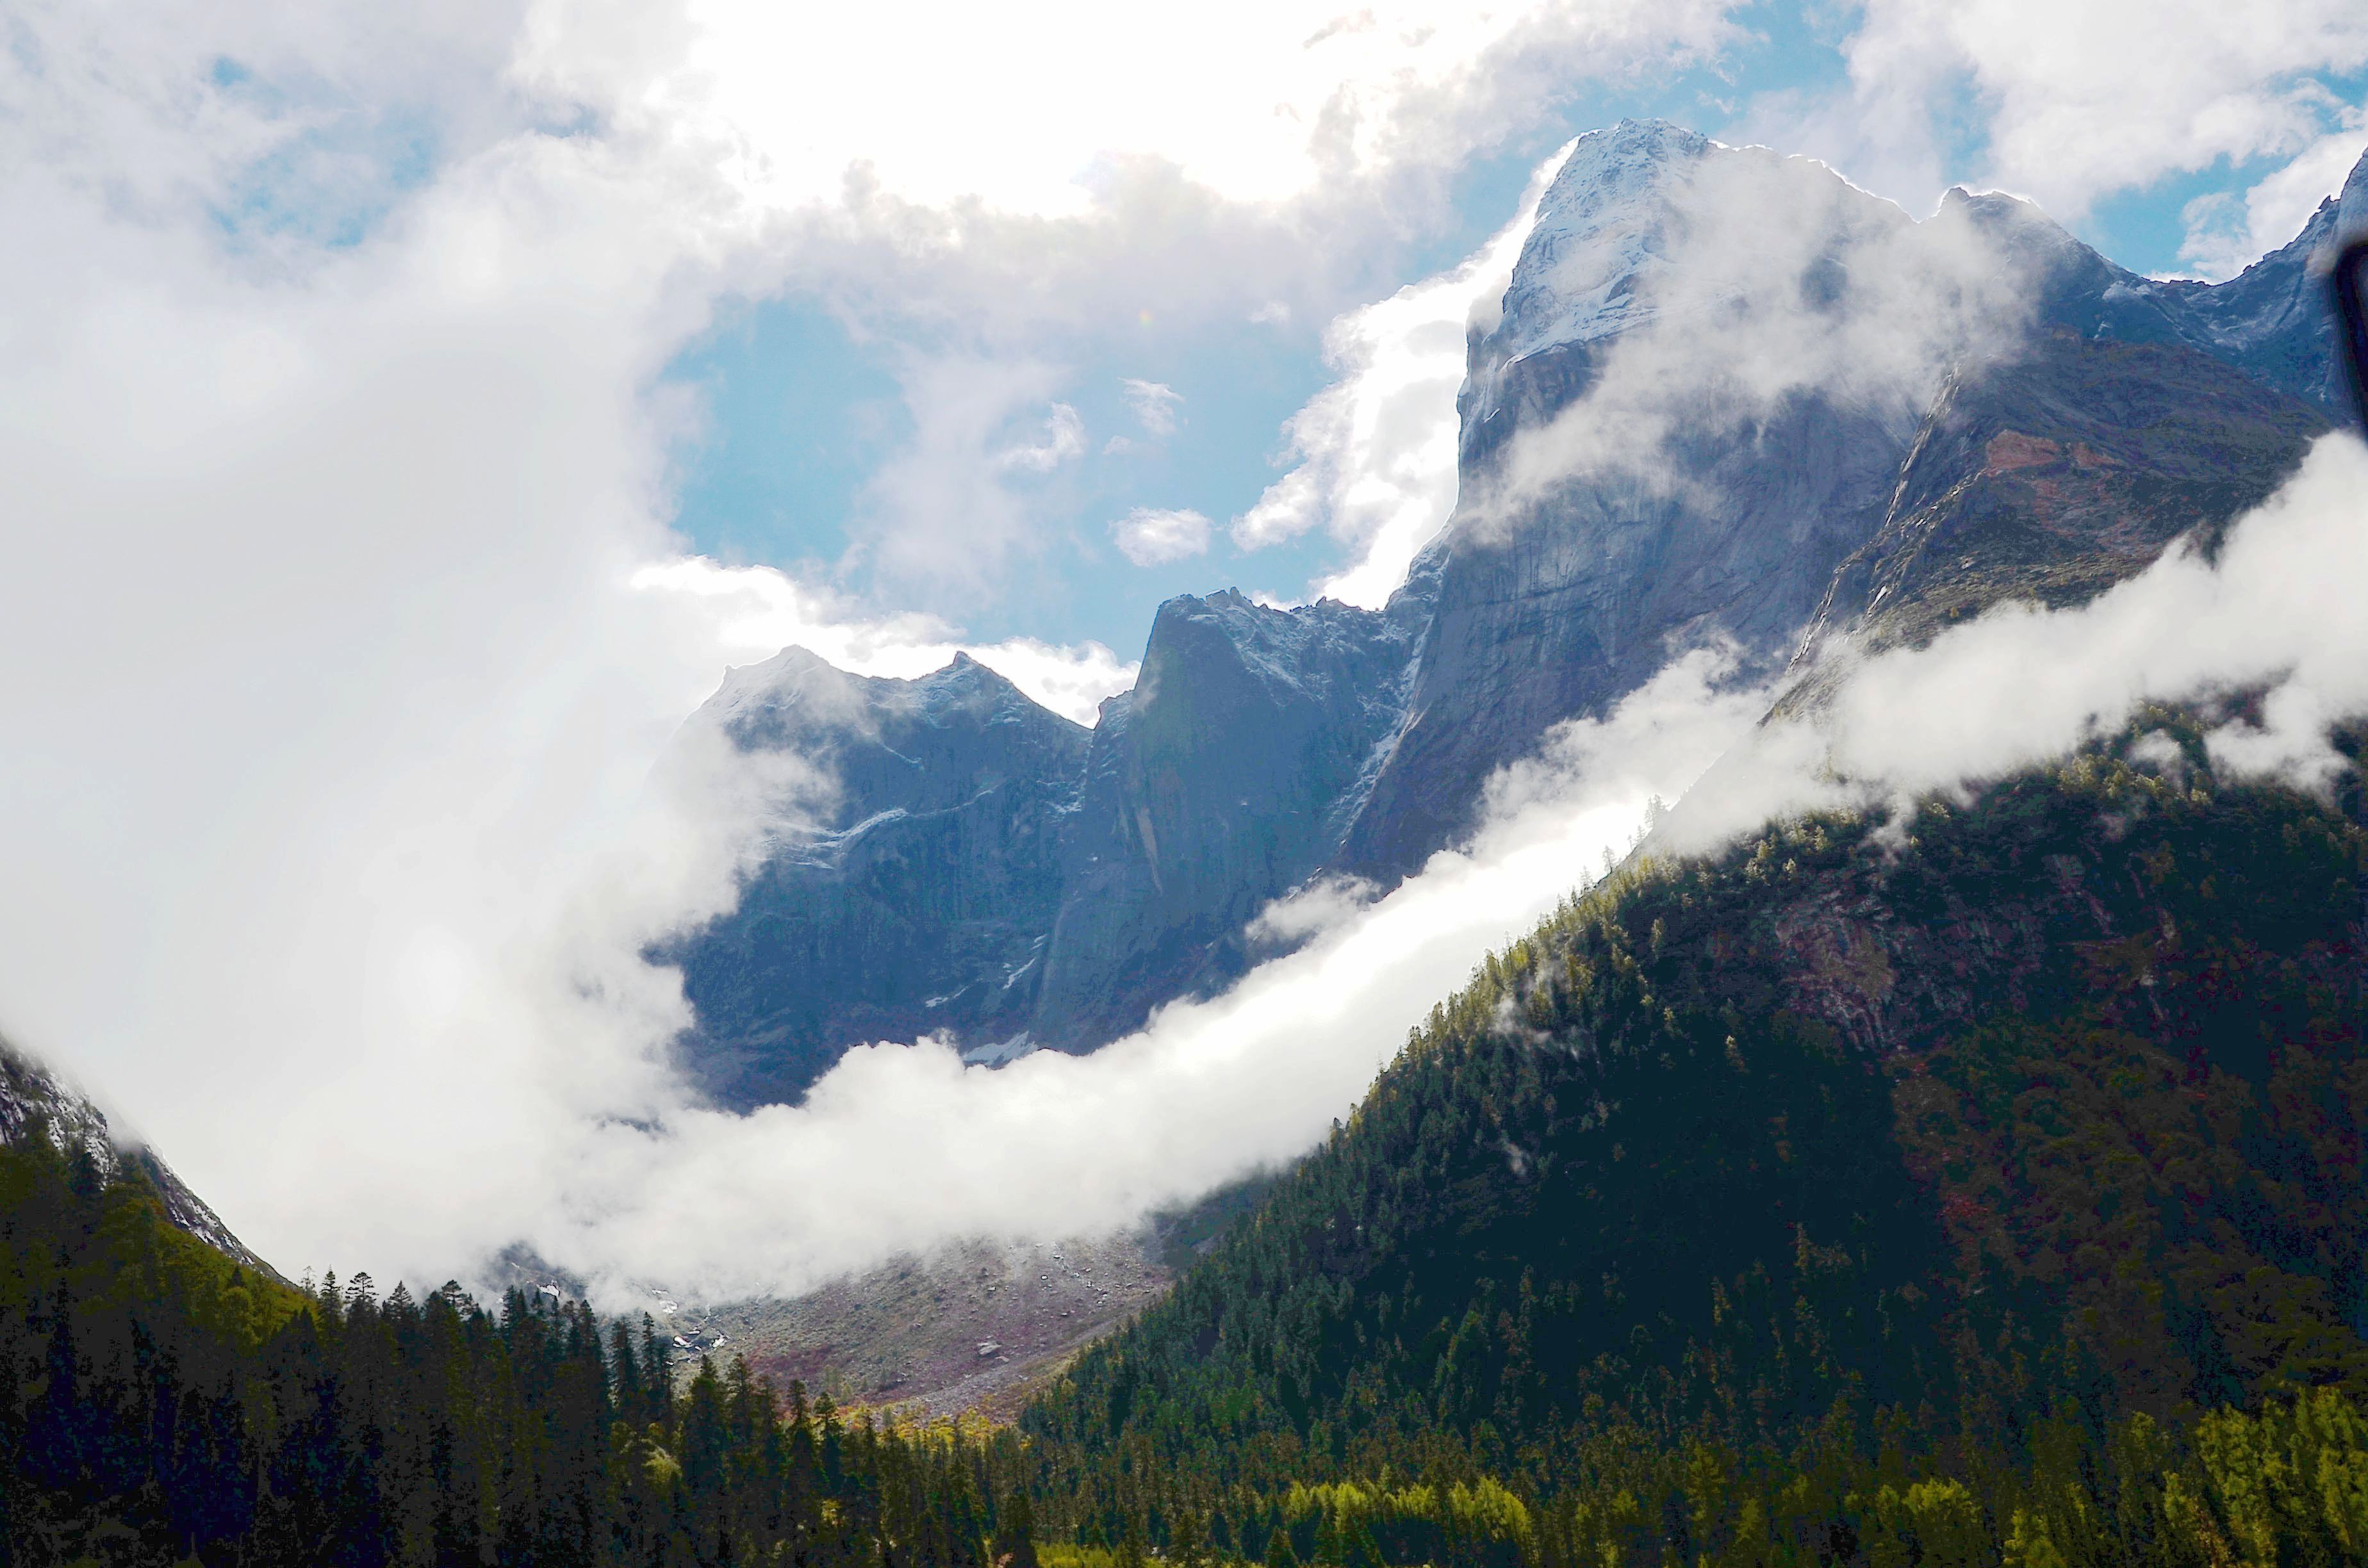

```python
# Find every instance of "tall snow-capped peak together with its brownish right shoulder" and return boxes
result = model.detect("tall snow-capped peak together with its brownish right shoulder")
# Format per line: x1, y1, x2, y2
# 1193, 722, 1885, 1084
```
1343, 123, 2339, 881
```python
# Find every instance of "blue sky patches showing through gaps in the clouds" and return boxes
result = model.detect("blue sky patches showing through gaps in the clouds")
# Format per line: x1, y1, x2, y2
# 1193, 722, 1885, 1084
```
666, 4, 2368, 656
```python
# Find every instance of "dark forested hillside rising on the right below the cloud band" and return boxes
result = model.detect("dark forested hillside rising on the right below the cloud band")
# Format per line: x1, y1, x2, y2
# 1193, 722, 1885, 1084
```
1025, 715, 2368, 1564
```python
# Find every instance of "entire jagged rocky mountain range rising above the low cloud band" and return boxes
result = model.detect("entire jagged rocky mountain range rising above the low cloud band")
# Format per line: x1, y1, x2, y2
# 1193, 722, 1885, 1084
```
670, 123, 2368, 1106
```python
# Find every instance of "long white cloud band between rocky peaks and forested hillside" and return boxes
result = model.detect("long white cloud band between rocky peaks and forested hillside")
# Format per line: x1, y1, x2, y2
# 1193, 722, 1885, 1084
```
535, 438, 2368, 1293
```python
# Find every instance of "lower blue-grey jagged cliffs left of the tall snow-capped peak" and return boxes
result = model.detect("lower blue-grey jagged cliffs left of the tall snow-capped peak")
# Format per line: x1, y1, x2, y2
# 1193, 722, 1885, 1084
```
677, 590, 1428, 1106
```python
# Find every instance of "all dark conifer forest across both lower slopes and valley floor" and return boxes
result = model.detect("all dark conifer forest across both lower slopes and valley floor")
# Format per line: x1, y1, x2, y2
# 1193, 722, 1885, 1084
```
13, 713, 2368, 1568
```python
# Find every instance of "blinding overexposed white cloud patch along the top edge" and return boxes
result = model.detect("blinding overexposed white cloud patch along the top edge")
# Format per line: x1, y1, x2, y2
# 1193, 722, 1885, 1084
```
521, 0, 1726, 216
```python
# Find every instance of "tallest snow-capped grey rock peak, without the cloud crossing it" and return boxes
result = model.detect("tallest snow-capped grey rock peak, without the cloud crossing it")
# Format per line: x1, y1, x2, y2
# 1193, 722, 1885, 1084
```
1343, 121, 1913, 881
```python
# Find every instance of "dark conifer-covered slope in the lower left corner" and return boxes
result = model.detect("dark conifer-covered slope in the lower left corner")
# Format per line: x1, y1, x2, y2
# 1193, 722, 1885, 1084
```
0, 1139, 1035, 1568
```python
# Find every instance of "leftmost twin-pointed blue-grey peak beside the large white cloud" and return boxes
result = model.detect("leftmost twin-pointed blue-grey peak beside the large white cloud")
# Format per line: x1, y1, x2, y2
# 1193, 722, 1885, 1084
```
666, 649, 1089, 1104
